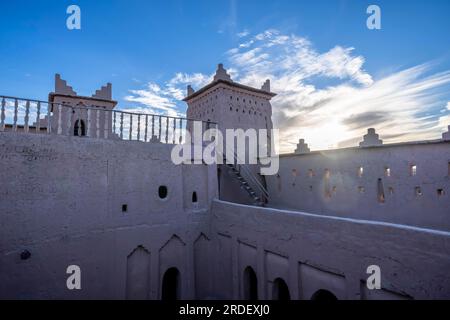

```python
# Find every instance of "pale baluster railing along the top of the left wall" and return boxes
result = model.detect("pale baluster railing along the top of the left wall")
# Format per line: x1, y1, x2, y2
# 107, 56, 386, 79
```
0, 96, 216, 144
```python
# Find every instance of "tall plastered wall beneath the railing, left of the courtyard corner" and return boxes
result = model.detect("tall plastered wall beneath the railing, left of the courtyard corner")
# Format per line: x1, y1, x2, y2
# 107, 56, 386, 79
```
0, 132, 217, 299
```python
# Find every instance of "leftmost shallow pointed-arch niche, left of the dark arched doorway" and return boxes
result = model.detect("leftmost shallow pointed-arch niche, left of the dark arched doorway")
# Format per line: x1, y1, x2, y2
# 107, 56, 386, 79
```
126, 246, 150, 300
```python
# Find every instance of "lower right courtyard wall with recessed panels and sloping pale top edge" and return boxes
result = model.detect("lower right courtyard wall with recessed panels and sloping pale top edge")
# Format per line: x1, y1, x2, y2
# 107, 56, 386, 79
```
211, 201, 450, 299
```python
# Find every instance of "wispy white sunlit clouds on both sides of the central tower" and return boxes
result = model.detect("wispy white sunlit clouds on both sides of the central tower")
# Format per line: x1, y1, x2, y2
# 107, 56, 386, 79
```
127, 30, 450, 152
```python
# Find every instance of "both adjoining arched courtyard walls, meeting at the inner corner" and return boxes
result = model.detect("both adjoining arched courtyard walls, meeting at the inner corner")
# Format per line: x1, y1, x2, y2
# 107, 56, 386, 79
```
0, 132, 450, 299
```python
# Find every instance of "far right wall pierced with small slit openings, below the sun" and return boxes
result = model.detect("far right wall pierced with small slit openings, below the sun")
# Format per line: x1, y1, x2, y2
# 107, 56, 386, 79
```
266, 141, 450, 231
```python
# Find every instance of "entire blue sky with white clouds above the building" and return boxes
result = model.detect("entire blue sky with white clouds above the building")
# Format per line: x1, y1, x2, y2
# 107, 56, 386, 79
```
0, 0, 450, 149
